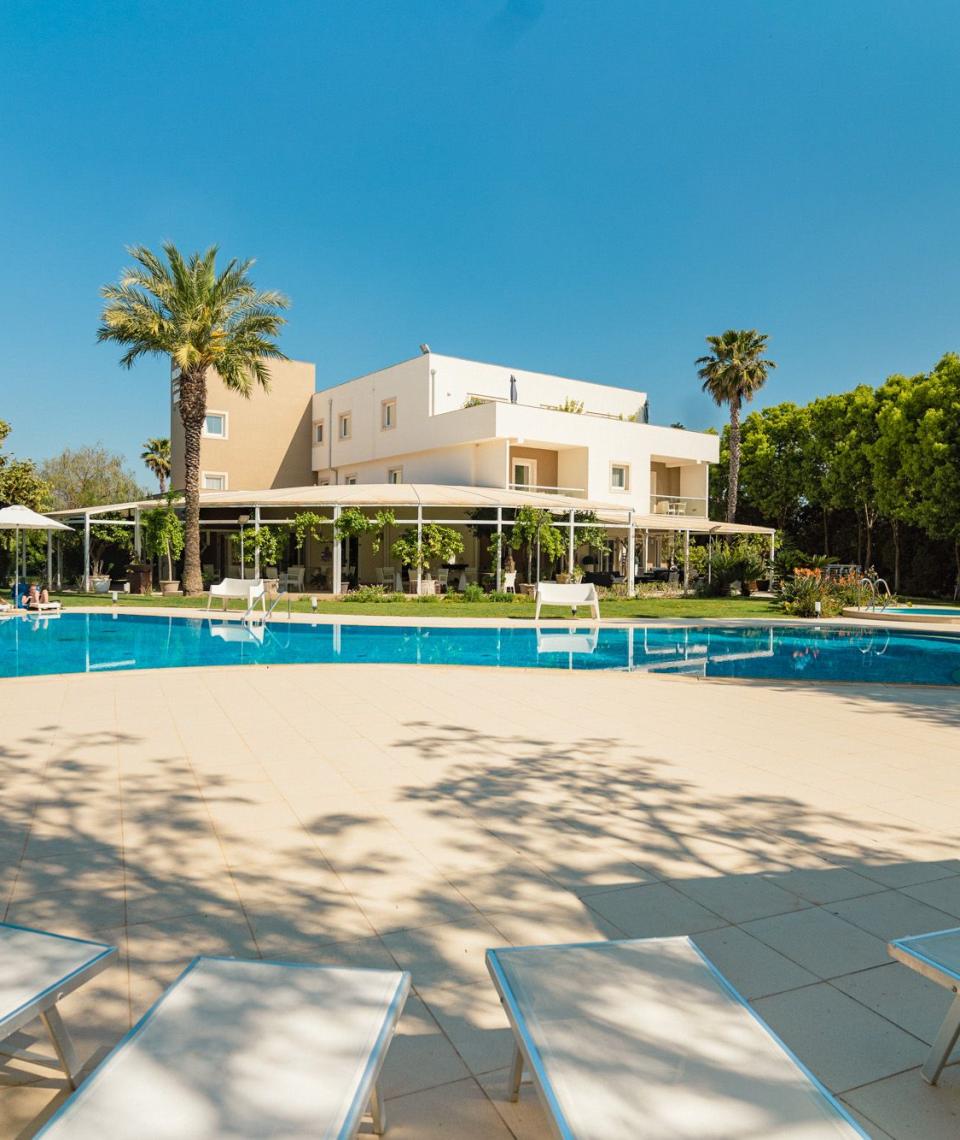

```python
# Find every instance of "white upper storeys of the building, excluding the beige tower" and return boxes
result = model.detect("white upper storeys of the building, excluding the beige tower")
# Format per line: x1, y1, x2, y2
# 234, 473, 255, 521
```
311, 352, 719, 516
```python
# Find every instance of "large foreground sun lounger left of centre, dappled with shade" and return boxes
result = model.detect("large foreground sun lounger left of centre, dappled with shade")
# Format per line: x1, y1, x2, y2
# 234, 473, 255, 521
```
38, 958, 410, 1140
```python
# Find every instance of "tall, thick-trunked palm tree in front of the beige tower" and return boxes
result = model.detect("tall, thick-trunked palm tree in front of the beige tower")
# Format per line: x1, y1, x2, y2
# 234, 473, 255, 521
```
97, 242, 290, 594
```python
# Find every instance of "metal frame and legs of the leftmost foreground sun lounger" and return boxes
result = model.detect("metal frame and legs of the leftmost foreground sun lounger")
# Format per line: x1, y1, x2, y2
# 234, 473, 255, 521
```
0, 922, 117, 1089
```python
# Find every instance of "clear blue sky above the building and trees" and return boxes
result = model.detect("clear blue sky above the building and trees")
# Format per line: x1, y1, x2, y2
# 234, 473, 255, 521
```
0, 0, 960, 479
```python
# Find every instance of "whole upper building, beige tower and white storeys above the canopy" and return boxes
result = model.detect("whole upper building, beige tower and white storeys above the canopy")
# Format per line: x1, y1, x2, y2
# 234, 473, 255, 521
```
171, 351, 719, 518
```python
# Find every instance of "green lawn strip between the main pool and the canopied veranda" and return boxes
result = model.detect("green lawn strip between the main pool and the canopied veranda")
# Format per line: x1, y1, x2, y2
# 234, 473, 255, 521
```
22, 594, 782, 620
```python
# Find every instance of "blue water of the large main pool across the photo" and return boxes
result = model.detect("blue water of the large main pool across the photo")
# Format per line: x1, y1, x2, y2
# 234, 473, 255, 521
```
0, 612, 960, 685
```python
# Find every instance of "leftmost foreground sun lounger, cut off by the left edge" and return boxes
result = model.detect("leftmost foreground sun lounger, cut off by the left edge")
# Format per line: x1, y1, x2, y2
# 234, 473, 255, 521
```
0, 922, 116, 1088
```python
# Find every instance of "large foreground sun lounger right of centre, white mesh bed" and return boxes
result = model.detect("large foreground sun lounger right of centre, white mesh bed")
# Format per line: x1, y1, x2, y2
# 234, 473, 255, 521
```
487, 938, 867, 1140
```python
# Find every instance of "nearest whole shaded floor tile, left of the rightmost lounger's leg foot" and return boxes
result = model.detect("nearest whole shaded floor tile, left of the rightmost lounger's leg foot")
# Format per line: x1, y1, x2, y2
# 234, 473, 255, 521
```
752, 982, 927, 1092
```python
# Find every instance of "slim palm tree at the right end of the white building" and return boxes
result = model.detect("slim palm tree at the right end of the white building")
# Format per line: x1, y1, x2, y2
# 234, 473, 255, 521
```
697, 328, 776, 522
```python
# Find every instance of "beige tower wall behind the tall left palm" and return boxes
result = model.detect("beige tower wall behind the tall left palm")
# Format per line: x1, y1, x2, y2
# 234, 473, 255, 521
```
170, 360, 316, 490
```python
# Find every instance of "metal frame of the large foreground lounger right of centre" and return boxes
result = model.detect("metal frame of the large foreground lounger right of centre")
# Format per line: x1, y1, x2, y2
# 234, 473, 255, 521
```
487, 938, 870, 1140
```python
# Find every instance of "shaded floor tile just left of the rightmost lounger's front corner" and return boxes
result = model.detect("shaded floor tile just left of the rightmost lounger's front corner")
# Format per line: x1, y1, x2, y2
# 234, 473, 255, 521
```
743, 907, 889, 978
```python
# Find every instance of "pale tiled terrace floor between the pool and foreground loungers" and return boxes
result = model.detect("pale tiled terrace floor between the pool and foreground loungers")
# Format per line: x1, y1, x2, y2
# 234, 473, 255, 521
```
0, 666, 960, 1140
